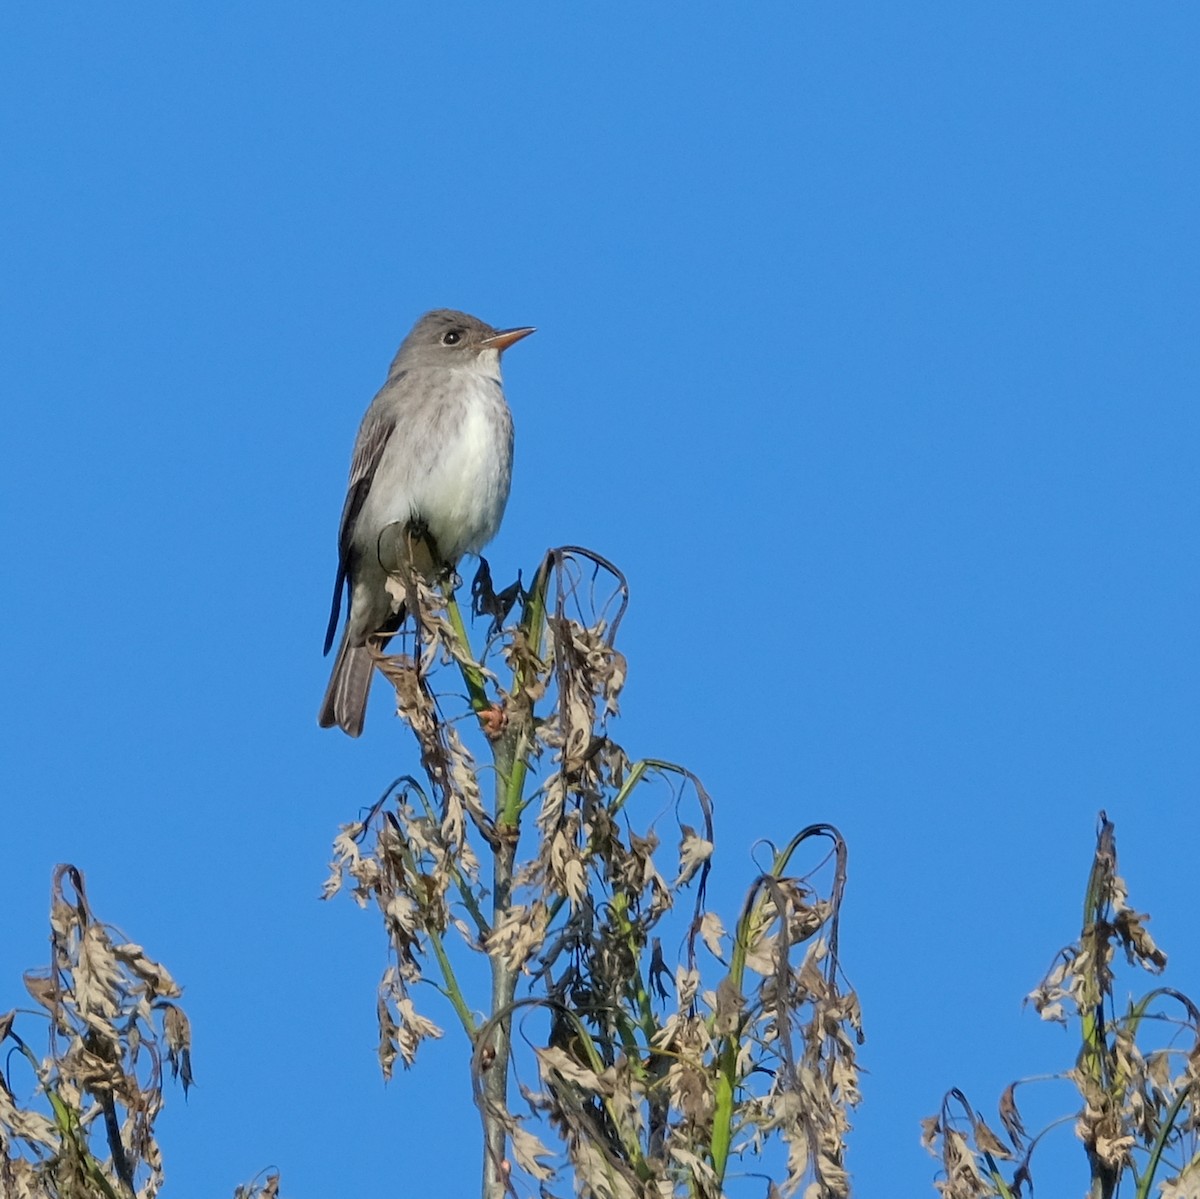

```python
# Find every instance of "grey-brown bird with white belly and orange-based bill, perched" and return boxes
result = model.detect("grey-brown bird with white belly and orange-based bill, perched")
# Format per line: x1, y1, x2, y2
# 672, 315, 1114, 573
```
318, 308, 534, 737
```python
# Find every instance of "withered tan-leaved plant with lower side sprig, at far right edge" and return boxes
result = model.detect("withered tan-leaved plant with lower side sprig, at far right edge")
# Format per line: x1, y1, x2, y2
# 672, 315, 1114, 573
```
924, 813, 1200, 1199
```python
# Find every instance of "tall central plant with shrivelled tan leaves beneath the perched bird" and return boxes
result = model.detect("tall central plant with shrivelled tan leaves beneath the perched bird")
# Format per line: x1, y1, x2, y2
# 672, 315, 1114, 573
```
325, 547, 862, 1199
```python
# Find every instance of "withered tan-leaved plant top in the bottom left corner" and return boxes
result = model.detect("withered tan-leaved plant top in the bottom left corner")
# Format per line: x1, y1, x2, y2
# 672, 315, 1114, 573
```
0, 865, 192, 1199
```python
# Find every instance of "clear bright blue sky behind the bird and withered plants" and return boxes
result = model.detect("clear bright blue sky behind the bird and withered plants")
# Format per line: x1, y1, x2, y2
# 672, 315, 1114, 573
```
0, 0, 1200, 1199
